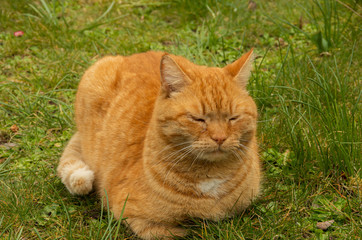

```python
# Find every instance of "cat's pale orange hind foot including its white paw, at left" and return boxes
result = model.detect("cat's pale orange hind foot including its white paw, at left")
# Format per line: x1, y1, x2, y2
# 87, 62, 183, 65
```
57, 132, 94, 194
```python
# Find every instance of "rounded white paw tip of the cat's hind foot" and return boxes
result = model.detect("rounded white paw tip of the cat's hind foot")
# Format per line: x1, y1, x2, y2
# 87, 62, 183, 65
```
68, 167, 94, 195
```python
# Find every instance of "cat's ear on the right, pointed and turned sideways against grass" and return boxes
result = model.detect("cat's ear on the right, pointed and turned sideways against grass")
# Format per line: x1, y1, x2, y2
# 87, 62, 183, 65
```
225, 49, 254, 87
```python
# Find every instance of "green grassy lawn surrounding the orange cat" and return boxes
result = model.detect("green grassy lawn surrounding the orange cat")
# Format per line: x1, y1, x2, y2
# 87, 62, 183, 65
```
0, 0, 362, 239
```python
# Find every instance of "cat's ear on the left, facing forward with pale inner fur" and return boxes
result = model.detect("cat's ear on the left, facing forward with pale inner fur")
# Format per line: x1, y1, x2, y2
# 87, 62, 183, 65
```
161, 54, 188, 97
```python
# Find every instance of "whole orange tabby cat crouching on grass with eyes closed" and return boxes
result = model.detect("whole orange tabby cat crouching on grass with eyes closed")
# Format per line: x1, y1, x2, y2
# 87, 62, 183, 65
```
58, 51, 261, 239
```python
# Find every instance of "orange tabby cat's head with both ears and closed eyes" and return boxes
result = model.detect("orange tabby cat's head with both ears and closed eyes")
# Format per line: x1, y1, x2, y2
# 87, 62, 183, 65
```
155, 50, 257, 161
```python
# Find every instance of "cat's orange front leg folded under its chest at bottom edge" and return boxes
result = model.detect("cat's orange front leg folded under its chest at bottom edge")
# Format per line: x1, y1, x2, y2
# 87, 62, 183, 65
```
127, 218, 187, 240
